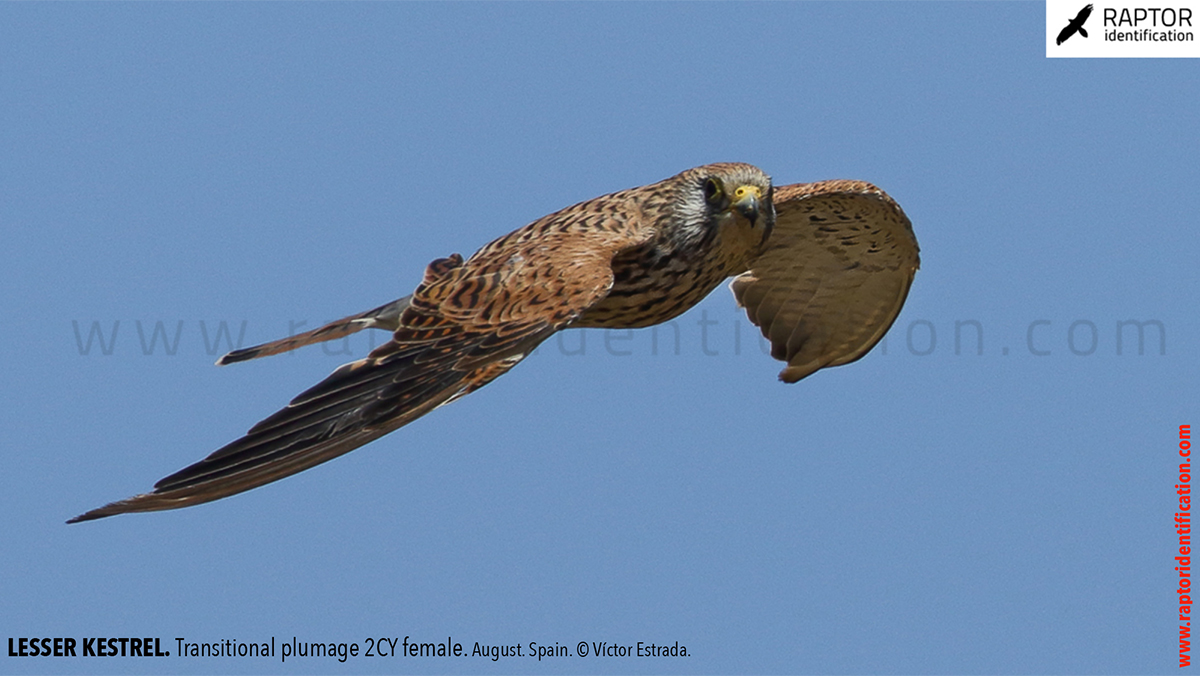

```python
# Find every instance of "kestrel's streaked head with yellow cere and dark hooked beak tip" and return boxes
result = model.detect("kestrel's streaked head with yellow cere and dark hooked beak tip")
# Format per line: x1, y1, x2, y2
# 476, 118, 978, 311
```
668, 163, 775, 259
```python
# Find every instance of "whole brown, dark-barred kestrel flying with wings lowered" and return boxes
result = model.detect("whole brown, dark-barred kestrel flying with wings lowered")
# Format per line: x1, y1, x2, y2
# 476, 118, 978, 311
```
68, 163, 919, 524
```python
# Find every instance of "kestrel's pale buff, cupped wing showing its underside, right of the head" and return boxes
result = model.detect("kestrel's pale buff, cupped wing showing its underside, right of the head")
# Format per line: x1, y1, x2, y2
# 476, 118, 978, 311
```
730, 180, 919, 383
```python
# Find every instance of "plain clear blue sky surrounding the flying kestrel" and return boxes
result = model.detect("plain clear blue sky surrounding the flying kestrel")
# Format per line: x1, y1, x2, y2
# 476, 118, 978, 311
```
0, 2, 1200, 674
